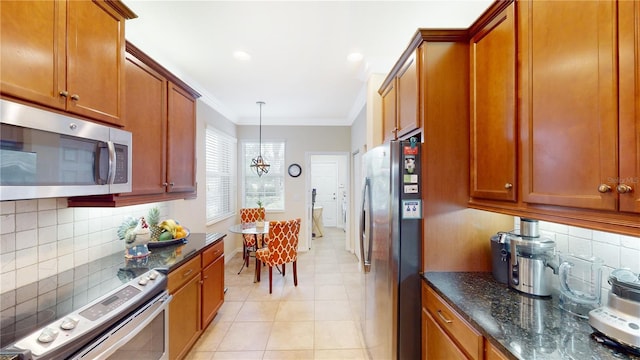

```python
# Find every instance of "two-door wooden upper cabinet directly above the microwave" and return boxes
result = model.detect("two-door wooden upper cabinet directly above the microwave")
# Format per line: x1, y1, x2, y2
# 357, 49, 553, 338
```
0, 0, 136, 126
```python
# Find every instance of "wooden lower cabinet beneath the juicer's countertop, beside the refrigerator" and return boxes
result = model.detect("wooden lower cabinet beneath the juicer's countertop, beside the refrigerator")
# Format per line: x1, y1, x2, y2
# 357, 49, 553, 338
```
422, 283, 507, 360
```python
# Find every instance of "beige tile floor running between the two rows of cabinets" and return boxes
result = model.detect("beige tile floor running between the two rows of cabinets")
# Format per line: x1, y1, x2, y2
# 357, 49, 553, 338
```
187, 228, 367, 360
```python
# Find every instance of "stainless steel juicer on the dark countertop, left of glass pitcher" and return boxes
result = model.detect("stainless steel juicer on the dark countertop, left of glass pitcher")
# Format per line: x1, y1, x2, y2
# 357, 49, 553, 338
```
507, 218, 557, 296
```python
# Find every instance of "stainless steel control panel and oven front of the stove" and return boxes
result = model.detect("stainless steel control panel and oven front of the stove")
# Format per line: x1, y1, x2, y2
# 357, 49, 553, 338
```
2, 270, 171, 360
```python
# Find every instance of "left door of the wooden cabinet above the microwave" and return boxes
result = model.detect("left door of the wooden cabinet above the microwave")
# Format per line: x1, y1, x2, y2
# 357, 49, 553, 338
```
0, 1, 67, 109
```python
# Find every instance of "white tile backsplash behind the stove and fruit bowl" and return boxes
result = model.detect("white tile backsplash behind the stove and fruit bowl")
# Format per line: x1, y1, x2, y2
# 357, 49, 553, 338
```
0, 198, 168, 294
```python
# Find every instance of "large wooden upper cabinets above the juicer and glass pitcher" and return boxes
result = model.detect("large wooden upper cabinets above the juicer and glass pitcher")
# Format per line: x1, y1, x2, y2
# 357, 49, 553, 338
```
469, 0, 640, 236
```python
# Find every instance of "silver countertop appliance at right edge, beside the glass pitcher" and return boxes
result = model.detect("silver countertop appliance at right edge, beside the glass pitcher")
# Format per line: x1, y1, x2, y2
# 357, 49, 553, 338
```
589, 269, 640, 355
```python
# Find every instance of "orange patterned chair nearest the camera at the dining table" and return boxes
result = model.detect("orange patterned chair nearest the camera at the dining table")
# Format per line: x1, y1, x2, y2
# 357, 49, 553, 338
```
256, 218, 300, 294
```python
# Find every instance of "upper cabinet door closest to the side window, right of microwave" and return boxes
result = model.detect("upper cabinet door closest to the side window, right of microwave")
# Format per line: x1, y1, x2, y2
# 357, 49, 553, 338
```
167, 82, 196, 192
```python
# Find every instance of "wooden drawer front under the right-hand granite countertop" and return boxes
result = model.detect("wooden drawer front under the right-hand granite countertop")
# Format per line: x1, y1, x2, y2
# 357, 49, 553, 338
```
422, 286, 483, 360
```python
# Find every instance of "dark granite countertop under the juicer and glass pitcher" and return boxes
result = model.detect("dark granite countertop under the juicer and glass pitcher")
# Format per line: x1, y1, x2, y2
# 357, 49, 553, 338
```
423, 272, 640, 360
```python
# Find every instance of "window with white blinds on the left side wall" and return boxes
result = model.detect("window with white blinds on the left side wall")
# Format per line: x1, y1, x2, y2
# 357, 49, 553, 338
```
206, 125, 237, 224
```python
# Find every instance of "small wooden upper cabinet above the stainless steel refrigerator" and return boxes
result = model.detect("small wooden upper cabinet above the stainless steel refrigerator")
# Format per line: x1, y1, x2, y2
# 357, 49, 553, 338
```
380, 50, 420, 142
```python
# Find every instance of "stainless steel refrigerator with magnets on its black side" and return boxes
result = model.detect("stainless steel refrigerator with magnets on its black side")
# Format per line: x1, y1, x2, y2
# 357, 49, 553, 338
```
360, 138, 422, 360
